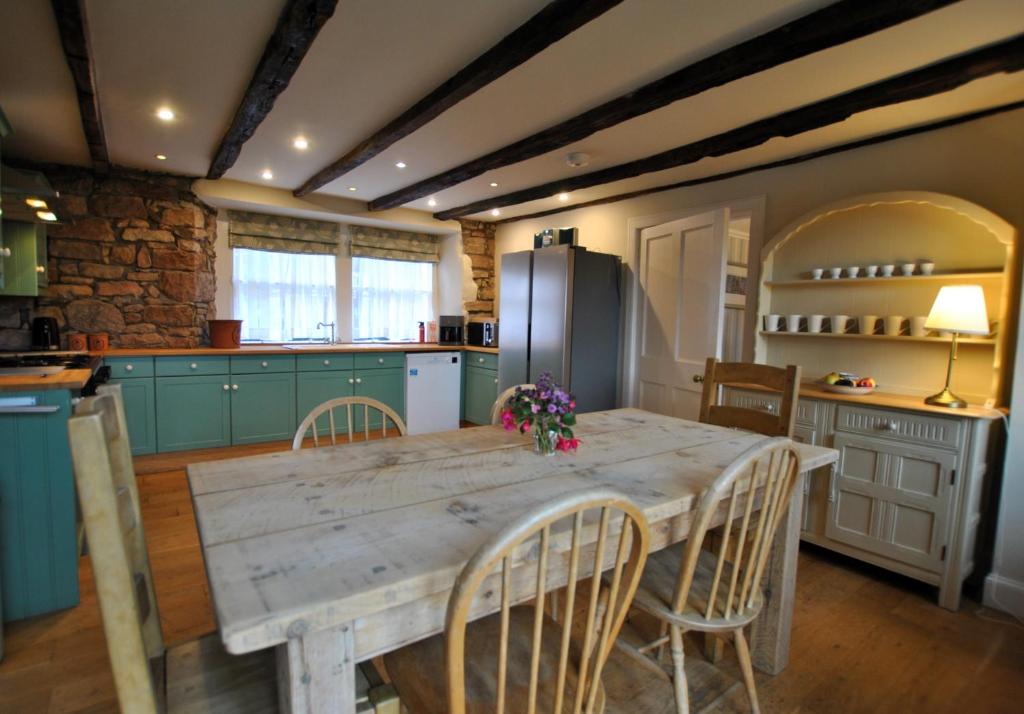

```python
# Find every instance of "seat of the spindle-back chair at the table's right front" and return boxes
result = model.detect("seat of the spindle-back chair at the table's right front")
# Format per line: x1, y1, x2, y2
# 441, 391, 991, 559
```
633, 543, 764, 632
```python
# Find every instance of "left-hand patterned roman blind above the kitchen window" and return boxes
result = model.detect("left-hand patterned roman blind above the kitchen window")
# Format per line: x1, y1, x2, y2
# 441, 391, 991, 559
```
227, 211, 341, 255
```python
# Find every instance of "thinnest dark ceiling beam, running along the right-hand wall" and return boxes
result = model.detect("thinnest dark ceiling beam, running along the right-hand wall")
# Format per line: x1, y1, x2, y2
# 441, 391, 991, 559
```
492, 99, 1024, 224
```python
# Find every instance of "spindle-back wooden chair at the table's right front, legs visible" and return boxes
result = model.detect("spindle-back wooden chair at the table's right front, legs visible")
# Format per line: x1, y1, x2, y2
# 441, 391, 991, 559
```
620, 437, 800, 714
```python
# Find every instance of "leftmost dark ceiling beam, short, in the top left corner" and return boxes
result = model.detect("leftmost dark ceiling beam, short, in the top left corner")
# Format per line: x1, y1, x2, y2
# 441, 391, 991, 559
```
52, 0, 111, 171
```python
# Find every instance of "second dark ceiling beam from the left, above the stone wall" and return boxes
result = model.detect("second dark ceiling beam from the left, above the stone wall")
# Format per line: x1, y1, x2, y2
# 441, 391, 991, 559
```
206, 0, 338, 178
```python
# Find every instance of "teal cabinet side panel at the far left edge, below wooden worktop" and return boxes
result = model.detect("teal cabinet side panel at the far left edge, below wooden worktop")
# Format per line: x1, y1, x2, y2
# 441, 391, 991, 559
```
0, 389, 79, 620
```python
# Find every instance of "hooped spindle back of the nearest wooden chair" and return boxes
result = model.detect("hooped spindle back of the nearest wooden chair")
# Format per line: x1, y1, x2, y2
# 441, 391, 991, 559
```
445, 489, 648, 714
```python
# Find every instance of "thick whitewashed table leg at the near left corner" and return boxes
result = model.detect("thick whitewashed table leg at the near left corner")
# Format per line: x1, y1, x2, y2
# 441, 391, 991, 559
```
278, 624, 355, 714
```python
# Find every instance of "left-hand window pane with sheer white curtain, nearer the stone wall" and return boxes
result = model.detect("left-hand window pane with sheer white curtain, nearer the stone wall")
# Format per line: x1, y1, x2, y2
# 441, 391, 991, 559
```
232, 248, 337, 342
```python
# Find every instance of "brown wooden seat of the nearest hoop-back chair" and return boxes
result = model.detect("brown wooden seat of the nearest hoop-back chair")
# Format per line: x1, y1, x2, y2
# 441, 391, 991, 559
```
384, 605, 604, 714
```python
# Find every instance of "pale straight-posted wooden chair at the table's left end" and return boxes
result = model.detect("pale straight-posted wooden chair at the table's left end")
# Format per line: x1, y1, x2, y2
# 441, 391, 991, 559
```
68, 385, 278, 714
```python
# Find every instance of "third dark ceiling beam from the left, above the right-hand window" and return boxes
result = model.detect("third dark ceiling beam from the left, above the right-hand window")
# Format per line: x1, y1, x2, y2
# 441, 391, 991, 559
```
295, 0, 623, 196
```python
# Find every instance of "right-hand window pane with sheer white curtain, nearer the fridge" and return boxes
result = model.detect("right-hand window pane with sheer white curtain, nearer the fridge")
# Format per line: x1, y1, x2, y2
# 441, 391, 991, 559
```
352, 258, 434, 340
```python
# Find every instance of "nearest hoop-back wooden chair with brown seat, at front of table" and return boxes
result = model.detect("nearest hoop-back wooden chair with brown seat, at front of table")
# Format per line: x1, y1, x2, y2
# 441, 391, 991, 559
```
384, 489, 648, 714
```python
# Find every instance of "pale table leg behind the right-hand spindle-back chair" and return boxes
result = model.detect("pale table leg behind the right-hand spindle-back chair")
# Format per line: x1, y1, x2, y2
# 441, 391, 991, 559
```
751, 473, 807, 674
